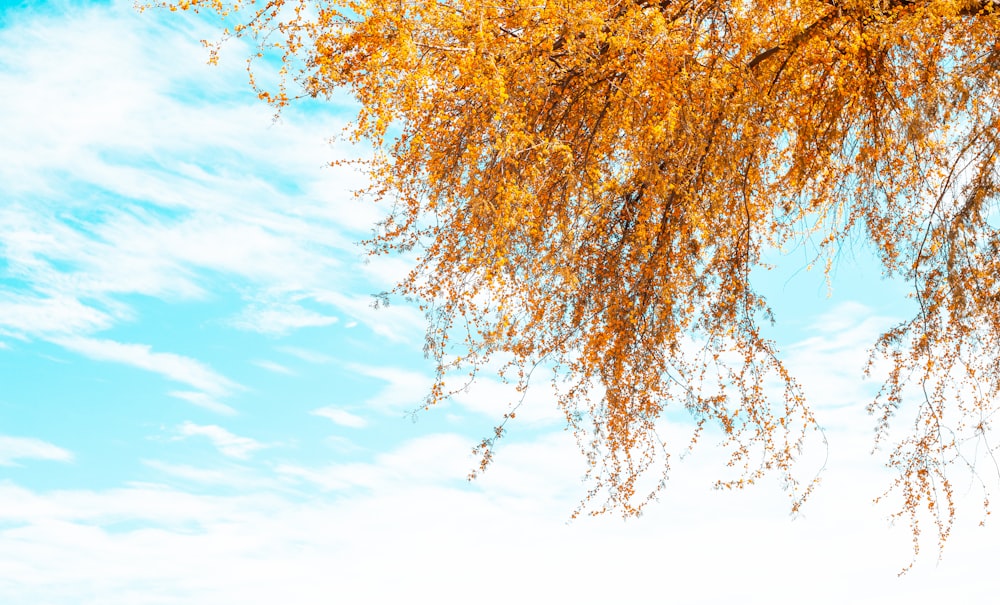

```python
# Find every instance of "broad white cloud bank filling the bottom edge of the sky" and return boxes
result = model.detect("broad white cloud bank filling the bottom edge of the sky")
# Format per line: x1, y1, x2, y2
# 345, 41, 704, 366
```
0, 428, 1000, 605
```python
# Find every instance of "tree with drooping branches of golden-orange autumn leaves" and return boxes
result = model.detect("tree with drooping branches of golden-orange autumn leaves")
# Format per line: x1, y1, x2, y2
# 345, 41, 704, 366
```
154, 0, 1000, 564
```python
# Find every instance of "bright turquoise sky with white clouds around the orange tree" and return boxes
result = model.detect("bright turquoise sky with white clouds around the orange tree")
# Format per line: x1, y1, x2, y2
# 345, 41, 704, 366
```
0, 0, 1000, 605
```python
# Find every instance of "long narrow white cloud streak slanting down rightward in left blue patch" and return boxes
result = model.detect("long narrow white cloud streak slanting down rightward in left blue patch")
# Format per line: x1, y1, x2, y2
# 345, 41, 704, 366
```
53, 337, 242, 397
